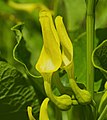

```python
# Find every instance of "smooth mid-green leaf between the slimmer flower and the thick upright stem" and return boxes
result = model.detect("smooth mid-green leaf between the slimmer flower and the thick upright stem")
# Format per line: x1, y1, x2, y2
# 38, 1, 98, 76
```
73, 33, 87, 84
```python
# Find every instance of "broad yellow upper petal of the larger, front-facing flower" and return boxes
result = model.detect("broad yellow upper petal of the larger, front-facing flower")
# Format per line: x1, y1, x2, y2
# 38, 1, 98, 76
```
36, 11, 62, 74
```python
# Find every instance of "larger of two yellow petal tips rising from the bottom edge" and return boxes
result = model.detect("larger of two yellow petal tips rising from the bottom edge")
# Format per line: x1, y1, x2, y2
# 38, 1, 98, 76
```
39, 98, 49, 120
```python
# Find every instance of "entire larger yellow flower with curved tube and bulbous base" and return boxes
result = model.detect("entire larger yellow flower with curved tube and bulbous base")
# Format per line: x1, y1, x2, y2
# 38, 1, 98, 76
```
36, 11, 72, 110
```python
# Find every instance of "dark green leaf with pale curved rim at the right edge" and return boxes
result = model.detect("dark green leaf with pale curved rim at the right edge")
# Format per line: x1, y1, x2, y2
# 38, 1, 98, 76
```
92, 40, 107, 79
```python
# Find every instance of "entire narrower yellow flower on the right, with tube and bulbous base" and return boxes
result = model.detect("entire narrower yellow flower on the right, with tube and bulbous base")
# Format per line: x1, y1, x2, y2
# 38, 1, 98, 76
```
55, 16, 91, 104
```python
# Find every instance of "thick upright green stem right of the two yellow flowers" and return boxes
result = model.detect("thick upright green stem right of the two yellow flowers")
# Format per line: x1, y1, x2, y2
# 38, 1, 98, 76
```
86, 0, 95, 98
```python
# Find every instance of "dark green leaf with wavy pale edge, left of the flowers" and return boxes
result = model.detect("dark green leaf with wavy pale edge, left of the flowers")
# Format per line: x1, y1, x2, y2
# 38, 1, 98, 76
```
11, 23, 41, 78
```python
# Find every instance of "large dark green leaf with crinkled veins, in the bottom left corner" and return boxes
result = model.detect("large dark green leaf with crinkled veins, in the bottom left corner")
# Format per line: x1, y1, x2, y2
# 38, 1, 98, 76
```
0, 61, 40, 120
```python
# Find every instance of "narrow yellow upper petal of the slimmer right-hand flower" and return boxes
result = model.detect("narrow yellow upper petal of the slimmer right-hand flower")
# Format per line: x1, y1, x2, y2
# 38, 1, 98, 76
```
55, 16, 73, 66
